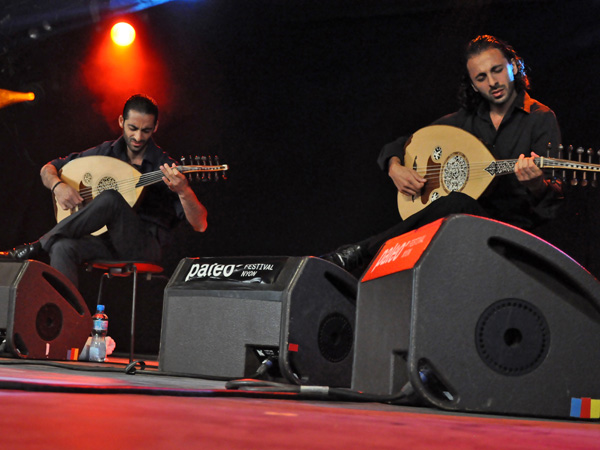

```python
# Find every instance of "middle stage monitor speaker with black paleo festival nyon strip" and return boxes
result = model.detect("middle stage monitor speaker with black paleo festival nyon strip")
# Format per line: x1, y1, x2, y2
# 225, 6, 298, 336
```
159, 257, 358, 387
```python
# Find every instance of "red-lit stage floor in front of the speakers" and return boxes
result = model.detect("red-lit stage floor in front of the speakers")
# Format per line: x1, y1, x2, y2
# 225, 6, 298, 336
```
0, 358, 600, 449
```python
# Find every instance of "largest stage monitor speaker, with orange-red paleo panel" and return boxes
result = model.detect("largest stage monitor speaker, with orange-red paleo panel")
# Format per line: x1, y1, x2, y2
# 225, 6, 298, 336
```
352, 215, 600, 418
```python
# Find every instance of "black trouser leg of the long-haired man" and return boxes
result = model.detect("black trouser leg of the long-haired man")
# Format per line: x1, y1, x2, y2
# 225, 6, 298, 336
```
358, 192, 488, 260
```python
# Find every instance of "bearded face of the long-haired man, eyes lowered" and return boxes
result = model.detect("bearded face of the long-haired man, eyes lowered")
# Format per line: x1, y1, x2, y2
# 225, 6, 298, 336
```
467, 48, 517, 106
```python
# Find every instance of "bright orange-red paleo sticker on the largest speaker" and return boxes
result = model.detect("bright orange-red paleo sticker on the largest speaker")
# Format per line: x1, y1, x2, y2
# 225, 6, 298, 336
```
361, 219, 444, 282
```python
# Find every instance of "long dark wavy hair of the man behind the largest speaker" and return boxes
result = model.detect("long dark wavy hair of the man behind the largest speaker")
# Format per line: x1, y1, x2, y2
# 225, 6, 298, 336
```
458, 34, 529, 111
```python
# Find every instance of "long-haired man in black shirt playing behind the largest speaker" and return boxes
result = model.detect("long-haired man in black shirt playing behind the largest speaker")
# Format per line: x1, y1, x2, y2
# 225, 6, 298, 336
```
322, 35, 562, 271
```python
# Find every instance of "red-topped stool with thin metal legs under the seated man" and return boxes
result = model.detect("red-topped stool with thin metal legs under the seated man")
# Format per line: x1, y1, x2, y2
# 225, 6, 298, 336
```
85, 260, 164, 362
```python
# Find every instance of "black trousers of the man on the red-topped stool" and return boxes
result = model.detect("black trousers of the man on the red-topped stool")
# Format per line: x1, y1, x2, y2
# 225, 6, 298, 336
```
40, 190, 162, 286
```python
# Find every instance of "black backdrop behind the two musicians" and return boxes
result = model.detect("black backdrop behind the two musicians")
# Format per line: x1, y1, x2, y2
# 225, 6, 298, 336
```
0, 0, 600, 352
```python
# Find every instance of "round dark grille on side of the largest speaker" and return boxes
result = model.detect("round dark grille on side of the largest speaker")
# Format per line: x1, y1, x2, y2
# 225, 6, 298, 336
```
475, 298, 550, 376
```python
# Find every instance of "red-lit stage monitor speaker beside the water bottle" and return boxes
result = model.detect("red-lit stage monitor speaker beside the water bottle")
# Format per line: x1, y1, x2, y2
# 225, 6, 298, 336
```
0, 260, 92, 360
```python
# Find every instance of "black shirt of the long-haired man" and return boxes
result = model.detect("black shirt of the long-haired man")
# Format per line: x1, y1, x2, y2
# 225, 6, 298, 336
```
377, 92, 562, 229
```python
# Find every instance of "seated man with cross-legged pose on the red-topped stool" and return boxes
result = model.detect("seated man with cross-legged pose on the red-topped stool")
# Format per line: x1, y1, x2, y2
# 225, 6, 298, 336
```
6, 94, 207, 286
